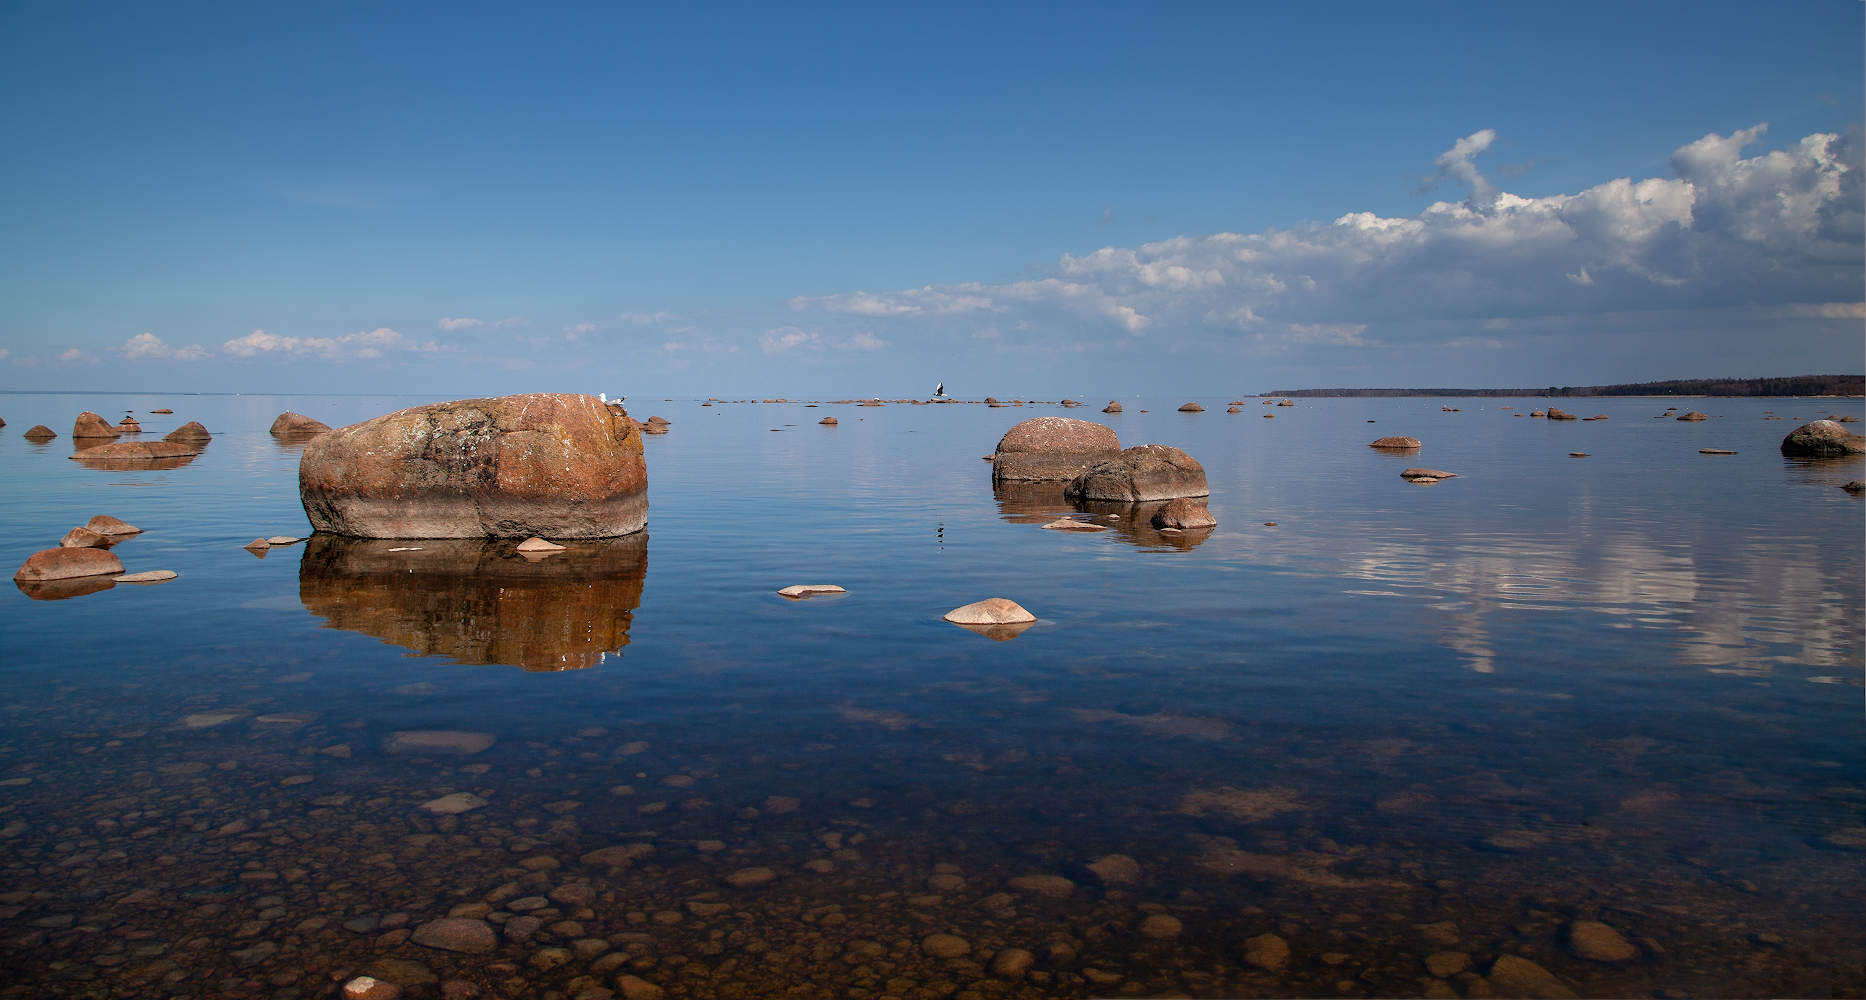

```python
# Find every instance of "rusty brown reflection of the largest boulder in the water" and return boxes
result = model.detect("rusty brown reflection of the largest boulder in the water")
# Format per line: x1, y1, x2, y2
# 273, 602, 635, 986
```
299, 532, 648, 670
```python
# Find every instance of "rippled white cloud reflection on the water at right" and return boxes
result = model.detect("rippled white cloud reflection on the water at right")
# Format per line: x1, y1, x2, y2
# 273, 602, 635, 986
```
1252, 532, 1859, 674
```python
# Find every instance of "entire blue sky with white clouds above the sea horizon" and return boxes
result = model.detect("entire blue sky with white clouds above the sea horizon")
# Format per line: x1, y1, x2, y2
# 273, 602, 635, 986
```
0, 0, 1866, 396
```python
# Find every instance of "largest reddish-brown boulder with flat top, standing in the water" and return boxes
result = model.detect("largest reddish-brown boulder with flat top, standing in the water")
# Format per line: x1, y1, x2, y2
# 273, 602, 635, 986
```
299, 392, 648, 539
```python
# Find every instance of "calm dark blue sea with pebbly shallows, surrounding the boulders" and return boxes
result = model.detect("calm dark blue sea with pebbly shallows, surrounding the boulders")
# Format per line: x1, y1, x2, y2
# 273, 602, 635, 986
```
0, 394, 1866, 1000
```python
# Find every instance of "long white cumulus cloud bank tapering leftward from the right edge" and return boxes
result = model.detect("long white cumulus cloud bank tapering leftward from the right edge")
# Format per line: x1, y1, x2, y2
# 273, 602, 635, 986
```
794, 125, 1866, 351
